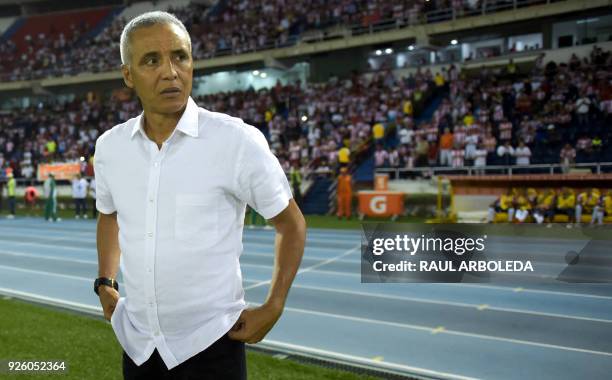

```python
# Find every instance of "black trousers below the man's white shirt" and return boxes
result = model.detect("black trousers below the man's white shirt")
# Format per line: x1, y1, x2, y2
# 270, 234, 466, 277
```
123, 334, 247, 380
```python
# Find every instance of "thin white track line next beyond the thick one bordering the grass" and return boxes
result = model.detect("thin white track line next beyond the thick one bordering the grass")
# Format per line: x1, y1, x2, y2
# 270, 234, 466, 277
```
0, 272, 612, 357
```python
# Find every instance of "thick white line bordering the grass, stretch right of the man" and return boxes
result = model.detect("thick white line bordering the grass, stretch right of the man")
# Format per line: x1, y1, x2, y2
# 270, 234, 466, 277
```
258, 339, 477, 380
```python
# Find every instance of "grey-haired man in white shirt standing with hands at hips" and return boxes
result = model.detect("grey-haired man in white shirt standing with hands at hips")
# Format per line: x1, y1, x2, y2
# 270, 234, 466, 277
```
94, 12, 306, 379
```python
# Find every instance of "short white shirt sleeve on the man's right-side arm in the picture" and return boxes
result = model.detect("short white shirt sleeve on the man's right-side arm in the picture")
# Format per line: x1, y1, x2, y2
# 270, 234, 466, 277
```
235, 125, 292, 219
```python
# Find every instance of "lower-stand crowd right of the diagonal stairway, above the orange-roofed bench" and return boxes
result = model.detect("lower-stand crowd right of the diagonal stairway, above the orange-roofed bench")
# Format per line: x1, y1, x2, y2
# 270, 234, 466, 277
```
375, 47, 612, 168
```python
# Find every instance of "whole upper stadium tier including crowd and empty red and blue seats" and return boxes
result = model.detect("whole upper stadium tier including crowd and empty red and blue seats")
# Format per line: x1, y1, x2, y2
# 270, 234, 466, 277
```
0, 0, 568, 81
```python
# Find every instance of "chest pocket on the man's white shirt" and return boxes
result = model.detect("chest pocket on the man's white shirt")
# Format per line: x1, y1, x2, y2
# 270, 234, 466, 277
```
174, 194, 219, 249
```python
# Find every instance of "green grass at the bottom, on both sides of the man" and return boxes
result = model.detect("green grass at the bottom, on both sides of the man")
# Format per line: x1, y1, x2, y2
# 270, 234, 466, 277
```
0, 299, 374, 380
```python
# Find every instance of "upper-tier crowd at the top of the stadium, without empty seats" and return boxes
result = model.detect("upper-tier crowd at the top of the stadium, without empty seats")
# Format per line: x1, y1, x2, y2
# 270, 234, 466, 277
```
0, 0, 544, 81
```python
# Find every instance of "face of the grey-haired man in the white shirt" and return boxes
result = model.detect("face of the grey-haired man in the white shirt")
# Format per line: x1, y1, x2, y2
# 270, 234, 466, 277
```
122, 24, 193, 114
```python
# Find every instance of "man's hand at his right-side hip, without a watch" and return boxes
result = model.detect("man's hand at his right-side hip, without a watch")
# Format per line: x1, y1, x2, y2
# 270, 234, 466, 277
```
228, 303, 283, 343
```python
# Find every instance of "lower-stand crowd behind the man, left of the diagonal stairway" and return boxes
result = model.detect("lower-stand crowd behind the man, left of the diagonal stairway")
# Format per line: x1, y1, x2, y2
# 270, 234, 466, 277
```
0, 70, 433, 178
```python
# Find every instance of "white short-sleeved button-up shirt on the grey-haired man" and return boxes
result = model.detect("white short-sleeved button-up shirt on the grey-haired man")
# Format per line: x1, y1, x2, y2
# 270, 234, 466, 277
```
95, 98, 291, 369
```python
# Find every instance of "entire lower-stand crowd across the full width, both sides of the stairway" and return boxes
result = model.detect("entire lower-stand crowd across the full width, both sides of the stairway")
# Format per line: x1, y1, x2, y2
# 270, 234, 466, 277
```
0, 43, 612, 184
